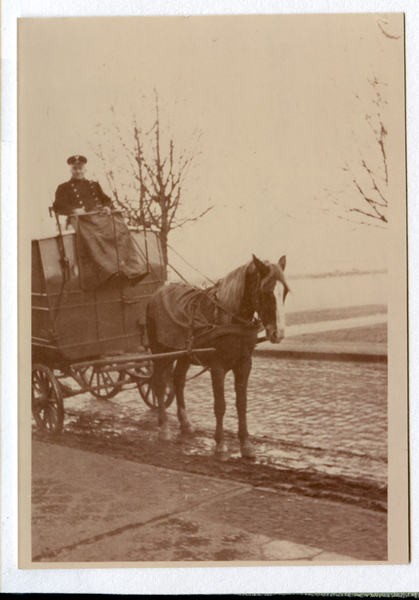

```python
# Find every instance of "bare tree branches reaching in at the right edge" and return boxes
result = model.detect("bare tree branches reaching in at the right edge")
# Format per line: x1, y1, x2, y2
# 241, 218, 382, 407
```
326, 76, 389, 227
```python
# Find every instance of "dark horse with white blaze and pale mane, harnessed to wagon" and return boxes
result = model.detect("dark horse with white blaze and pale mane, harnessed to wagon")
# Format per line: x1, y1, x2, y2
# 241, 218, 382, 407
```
146, 255, 289, 460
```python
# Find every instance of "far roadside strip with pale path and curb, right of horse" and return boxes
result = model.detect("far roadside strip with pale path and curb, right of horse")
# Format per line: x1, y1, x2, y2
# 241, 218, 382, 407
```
255, 306, 387, 363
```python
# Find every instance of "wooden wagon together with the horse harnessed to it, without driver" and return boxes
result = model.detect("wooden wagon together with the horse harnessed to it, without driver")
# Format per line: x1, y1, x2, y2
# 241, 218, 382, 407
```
32, 213, 289, 459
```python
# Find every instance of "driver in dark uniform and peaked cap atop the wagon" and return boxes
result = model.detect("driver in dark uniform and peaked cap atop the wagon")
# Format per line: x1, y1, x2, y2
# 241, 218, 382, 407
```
53, 155, 112, 216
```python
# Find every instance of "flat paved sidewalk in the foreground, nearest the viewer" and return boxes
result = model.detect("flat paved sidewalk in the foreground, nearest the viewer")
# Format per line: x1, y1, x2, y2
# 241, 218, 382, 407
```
28, 441, 387, 567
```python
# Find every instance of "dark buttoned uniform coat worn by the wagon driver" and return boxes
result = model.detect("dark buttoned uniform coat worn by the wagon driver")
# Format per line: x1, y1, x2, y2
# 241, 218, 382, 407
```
53, 178, 112, 215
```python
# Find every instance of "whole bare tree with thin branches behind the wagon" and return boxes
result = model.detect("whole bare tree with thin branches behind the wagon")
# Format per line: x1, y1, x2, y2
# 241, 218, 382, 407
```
94, 93, 212, 279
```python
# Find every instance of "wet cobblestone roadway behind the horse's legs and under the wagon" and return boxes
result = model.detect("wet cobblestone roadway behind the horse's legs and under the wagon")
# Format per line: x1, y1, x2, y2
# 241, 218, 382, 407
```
61, 356, 387, 487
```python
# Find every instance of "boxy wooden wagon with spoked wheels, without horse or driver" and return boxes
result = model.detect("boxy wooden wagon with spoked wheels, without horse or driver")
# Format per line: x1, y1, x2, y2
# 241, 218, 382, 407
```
32, 211, 213, 434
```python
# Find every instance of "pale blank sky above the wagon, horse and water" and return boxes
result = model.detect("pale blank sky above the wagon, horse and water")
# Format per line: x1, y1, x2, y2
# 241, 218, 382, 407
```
18, 14, 405, 280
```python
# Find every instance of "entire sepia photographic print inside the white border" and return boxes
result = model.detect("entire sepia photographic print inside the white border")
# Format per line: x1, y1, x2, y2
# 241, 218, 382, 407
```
17, 13, 409, 569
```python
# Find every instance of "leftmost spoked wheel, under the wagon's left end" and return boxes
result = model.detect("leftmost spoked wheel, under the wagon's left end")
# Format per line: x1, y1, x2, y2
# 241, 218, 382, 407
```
32, 365, 64, 435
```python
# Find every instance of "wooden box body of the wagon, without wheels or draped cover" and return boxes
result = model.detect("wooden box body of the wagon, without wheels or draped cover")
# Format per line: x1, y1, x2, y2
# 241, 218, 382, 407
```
32, 230, 164, 368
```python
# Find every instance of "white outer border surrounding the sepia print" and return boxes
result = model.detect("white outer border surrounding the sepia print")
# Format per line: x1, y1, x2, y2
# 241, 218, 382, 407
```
0, 0, 419, 595
